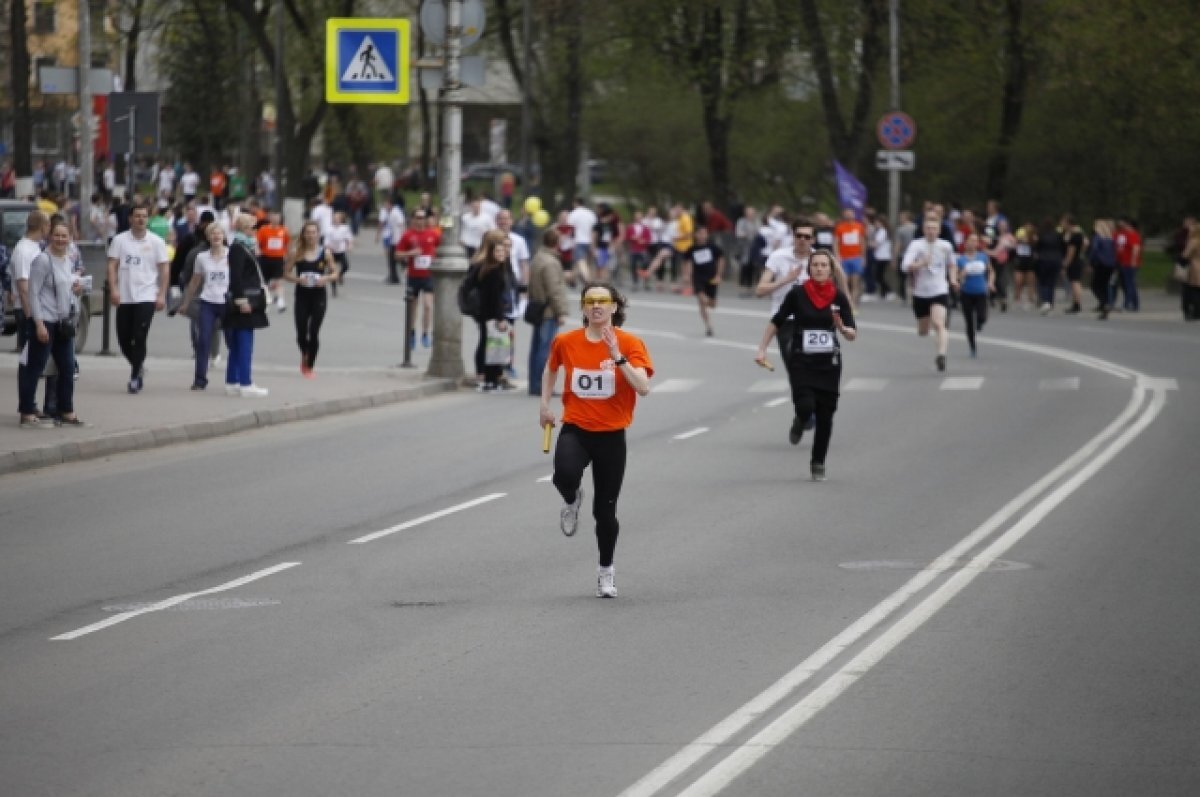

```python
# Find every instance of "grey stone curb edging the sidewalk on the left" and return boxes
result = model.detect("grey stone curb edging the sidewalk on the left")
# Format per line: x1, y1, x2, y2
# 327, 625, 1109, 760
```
0, 379, 458, 477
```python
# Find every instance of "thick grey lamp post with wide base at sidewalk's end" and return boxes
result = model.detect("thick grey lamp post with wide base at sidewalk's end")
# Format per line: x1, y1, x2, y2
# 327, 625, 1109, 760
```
426, 0, 467, 379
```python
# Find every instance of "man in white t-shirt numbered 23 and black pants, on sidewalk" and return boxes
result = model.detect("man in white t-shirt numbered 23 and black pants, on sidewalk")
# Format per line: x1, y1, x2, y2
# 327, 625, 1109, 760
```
108, 205, 169, 394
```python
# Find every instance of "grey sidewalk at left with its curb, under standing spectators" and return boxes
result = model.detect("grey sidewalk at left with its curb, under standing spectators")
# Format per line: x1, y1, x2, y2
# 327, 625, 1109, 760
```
0, 352, 456, 475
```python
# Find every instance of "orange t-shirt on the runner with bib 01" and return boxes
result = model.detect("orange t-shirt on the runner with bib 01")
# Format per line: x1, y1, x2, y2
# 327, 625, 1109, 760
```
547, 329, 654, 432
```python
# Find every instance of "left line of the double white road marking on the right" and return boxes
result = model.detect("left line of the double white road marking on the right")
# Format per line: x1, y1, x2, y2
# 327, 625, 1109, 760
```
619, 391, 1145, 797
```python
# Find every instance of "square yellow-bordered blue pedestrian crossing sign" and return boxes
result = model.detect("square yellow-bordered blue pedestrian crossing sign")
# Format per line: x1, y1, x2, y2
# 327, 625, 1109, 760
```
325, 18, 409, 104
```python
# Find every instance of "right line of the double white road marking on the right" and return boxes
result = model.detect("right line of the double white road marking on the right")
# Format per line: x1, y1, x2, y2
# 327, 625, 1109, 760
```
679, 389, 1166, 797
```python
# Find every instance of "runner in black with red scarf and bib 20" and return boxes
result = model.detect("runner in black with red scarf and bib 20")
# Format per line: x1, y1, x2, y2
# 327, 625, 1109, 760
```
756, 250, 858, 481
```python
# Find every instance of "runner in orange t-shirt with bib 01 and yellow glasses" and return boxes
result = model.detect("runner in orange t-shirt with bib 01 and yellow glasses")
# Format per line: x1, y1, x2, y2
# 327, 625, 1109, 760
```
538, 283, 654, 598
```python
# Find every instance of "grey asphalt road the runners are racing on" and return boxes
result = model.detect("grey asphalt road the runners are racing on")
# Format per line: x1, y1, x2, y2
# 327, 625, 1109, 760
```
0, 246, 1200, 797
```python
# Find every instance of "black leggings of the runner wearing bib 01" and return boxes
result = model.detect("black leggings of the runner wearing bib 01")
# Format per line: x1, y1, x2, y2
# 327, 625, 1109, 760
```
554, 424, 625, 568
